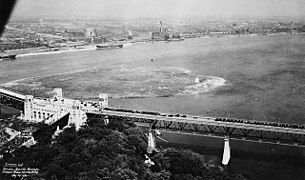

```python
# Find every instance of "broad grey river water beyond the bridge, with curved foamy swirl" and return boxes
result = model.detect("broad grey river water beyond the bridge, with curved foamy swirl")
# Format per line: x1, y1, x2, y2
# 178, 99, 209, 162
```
0, 35, 305, 179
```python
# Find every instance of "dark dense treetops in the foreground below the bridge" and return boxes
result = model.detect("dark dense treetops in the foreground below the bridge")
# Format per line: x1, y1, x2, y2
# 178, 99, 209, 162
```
1, 117, 251, 180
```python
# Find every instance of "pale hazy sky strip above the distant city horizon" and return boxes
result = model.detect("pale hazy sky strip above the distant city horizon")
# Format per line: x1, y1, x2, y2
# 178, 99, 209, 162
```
13, 0, 305, 18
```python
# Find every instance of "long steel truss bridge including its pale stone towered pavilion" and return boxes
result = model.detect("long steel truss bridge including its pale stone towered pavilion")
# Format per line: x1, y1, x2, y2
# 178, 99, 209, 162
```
0, 87, 305, 147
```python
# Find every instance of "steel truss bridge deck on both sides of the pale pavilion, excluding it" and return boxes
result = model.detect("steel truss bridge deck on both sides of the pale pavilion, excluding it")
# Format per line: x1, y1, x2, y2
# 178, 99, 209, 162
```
0, 87, 305, 146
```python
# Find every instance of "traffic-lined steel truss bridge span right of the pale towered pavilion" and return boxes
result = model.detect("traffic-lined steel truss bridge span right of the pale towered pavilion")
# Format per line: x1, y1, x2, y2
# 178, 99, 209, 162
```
94, 110, 305, 147
